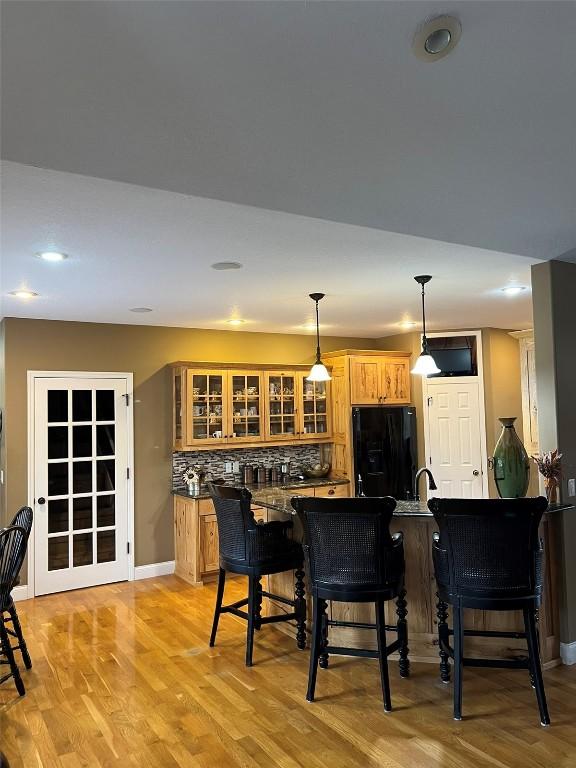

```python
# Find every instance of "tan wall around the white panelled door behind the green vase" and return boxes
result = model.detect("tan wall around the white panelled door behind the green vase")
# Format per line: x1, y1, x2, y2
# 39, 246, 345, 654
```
378, 328, 522, 497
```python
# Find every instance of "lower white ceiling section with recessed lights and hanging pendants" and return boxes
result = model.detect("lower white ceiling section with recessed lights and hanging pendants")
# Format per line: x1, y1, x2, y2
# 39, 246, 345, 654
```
1, 162, 535, 337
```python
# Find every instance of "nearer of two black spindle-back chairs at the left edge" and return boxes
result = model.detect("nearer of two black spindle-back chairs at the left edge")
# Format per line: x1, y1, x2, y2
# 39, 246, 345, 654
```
0, 525, 28, 696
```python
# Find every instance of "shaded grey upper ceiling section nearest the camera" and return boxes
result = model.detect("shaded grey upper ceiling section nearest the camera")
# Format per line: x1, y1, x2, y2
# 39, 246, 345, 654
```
2, 0, 576, 260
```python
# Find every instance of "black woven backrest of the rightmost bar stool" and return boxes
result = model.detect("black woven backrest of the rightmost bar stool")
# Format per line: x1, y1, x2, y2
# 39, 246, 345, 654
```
428, 496, 548, 597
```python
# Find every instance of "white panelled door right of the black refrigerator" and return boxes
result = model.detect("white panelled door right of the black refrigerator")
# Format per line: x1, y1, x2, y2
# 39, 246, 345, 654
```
427, 380, 486, 499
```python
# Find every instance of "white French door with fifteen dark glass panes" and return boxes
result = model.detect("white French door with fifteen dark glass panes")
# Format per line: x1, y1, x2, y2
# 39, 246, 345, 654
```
32, 377, 129, 595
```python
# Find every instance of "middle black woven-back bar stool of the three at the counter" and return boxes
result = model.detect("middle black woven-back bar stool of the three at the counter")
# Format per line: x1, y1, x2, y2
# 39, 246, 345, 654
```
292, 497, 410, 712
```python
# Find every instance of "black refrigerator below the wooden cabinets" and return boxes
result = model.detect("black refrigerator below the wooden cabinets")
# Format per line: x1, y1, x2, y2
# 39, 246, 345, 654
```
352, 406, 417, 499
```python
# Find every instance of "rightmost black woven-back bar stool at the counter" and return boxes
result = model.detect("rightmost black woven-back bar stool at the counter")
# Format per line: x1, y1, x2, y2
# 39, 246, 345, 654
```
428, 497, 550, 725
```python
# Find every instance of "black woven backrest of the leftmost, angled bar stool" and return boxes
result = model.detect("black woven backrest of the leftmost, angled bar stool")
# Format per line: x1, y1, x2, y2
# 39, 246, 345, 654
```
207, 483, 256, 561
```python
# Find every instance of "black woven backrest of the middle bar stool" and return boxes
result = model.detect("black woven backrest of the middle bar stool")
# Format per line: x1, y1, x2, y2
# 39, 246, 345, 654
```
292, 496, 404, 588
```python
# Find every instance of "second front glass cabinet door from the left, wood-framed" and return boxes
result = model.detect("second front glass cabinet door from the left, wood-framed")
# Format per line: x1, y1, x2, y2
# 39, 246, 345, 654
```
227, 371, 264, 443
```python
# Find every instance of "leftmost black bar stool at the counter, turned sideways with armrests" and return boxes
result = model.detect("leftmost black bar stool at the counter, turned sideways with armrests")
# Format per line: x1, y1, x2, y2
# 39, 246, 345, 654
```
208, 483, 306, 667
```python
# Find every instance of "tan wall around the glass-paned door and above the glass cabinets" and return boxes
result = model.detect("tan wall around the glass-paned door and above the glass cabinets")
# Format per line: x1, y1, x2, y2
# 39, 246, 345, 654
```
5, 318, 376, 580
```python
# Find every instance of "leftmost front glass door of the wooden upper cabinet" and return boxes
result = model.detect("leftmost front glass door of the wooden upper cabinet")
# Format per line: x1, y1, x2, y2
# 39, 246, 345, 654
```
186, 368, 228, 445
